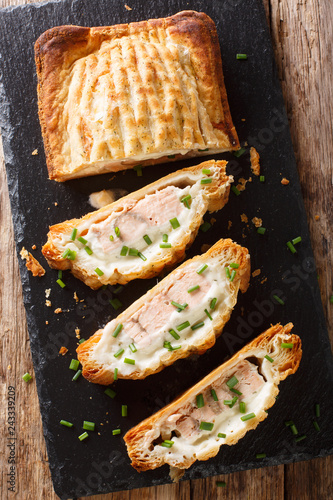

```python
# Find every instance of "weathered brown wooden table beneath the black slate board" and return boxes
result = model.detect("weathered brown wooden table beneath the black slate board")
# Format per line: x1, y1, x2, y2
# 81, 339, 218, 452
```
0, 0, 333, 500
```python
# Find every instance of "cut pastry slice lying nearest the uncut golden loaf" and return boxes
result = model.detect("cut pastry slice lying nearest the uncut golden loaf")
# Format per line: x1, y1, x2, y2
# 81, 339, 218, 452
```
42, 160, 233, 289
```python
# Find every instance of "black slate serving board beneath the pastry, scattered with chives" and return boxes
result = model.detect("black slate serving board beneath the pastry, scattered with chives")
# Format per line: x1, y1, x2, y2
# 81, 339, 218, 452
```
0, 0, 333, 499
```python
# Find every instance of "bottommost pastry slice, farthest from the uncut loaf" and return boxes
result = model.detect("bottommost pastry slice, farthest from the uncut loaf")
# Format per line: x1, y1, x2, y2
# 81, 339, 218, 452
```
124, 323, 302, 472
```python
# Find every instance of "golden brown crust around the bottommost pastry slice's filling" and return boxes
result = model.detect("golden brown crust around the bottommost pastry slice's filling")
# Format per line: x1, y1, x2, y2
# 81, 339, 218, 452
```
124, 323, 302, 472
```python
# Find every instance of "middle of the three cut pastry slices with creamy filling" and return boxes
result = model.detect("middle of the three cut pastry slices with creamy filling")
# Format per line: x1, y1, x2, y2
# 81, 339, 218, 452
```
77, 239, 250, 385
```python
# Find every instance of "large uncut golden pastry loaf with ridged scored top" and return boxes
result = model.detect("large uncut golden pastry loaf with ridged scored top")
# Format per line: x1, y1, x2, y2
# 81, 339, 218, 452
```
35, 11, 239, 181
